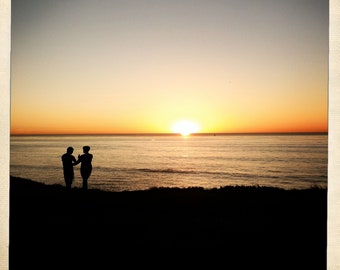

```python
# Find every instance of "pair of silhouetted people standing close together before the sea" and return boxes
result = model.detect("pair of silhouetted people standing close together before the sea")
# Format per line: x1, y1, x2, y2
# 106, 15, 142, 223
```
61, 146, 93, 189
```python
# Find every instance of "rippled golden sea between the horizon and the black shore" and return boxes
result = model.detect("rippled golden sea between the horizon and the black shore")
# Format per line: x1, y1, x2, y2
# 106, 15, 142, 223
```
10, 135, 328, 191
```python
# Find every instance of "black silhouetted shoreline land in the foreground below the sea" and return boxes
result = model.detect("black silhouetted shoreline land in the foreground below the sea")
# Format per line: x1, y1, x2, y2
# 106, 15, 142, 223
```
9, 177, 327, 270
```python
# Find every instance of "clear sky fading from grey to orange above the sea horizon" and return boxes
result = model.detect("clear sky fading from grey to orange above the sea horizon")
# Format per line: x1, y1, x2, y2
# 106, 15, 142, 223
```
11, 0, 329, 134
